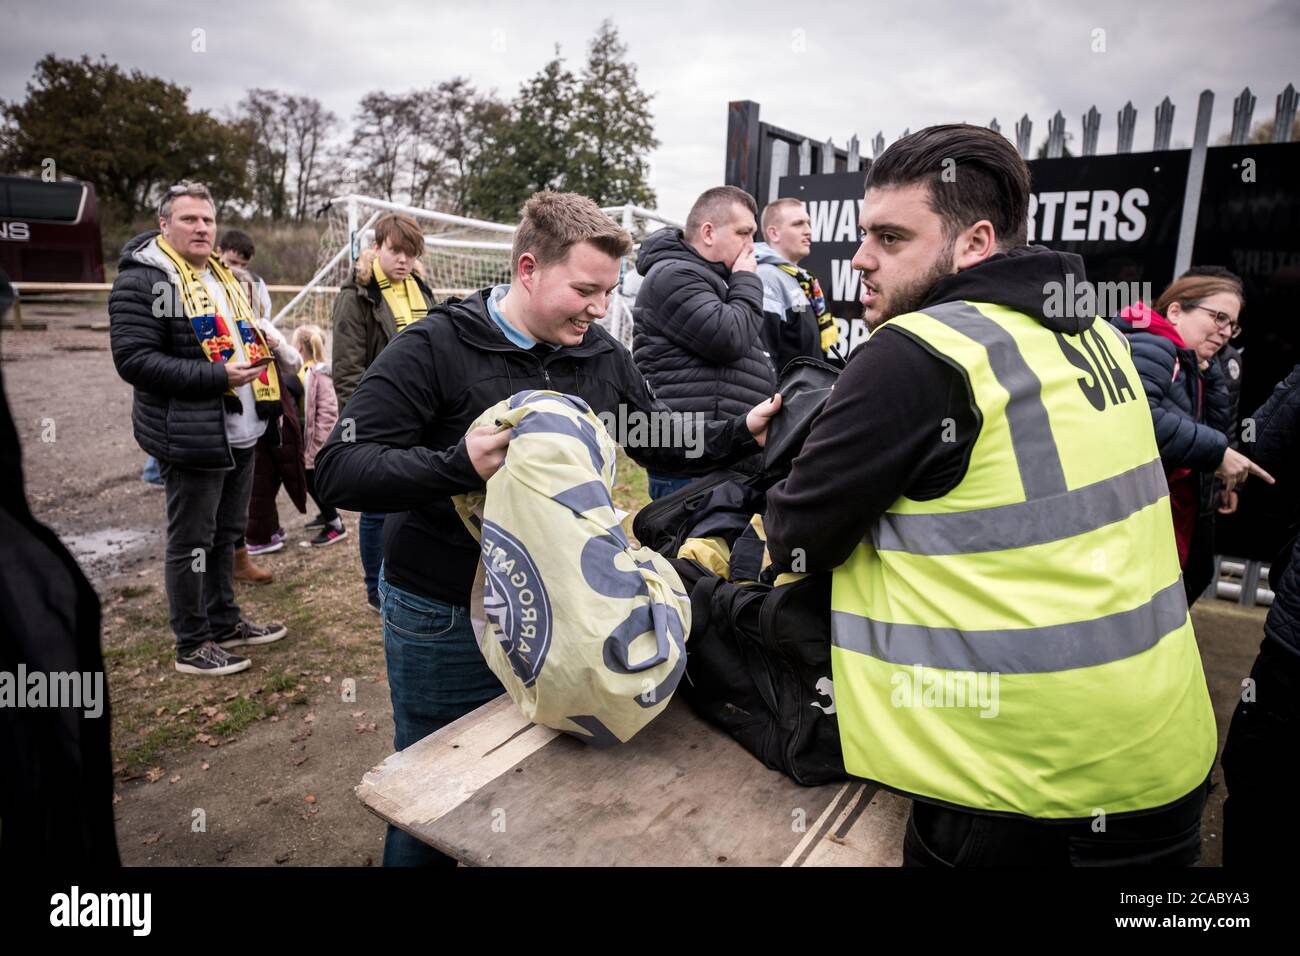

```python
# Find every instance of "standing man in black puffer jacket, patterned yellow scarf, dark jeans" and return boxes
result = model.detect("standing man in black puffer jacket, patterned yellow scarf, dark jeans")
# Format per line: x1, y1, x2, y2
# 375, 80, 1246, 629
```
108, 182, 286, 675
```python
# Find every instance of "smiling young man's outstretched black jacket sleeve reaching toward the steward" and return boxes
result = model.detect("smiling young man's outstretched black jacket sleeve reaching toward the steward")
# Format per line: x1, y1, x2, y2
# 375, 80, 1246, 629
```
608, 349, 759, 476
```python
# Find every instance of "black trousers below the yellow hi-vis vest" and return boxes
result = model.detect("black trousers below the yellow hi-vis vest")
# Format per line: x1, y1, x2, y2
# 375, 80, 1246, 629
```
902, 778, 1209, 866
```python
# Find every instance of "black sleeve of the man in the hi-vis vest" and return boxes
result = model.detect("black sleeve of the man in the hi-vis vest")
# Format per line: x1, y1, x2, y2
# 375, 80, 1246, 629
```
763, 325, 979, 571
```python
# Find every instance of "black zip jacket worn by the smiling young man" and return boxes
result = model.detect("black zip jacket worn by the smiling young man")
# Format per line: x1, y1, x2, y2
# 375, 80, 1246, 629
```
316, 290, 758, 606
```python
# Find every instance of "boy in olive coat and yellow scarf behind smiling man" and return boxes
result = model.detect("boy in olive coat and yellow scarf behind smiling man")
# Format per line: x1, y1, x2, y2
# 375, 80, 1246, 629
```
332, 212, 434, 611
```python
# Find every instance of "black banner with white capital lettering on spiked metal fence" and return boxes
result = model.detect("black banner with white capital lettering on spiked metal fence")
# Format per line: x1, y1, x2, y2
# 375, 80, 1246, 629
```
779, 143, 1300, 559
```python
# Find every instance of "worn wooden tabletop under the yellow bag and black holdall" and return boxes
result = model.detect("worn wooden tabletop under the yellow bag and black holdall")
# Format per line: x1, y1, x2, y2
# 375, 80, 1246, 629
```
358, 697, 906, 866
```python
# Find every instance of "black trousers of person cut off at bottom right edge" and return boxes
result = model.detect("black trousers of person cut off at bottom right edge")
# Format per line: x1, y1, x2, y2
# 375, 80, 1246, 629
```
1222, 637, 1300, 866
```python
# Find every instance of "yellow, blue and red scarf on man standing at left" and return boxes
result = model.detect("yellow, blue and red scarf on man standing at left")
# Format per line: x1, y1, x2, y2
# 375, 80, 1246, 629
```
157, 235, 280, 419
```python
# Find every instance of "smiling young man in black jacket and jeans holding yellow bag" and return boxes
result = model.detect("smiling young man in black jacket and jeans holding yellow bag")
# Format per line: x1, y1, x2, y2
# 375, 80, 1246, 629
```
316, 191, 779, 865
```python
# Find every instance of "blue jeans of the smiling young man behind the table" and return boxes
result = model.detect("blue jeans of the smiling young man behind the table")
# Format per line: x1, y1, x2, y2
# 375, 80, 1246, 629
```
380, 574, 504, 866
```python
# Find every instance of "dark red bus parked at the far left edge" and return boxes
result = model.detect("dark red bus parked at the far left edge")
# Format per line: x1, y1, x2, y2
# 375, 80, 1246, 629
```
0, 176, 104, 282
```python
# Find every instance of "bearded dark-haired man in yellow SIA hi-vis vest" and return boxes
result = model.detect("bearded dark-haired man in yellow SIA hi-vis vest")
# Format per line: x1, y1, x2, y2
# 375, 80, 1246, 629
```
766, 125, 1217, 865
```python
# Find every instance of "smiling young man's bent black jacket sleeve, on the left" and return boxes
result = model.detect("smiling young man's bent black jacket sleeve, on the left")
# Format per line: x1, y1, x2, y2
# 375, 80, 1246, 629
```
316, 323, 484, 512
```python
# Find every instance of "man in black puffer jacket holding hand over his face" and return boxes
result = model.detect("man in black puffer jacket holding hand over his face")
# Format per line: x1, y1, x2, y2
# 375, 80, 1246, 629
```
632, 186, 776, 498
